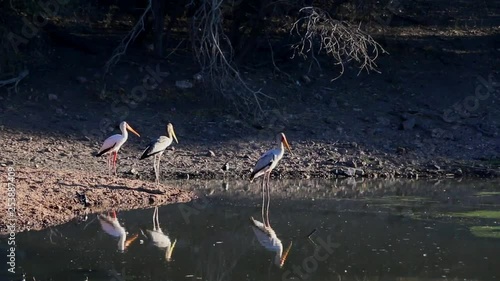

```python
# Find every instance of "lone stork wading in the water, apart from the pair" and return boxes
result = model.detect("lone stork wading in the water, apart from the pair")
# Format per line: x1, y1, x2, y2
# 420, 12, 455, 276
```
250, 133, 293, 221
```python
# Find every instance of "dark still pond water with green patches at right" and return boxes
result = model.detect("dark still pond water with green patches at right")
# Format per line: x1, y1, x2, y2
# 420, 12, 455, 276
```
0, 180, 500, 281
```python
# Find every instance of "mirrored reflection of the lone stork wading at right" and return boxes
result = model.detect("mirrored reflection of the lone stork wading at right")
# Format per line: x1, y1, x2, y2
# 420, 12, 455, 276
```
250, 173, 292, 267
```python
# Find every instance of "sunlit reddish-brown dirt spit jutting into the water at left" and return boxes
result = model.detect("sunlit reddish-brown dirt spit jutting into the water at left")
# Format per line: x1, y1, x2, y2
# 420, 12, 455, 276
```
0, 166, 196, 235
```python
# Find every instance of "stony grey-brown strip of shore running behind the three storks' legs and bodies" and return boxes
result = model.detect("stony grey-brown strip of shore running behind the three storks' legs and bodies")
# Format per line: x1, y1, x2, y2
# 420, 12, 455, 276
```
0, 124, 500, 185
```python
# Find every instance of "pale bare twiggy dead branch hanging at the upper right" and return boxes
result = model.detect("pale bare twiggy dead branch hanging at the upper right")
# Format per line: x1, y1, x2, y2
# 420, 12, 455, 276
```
290, 7, 387, 81
